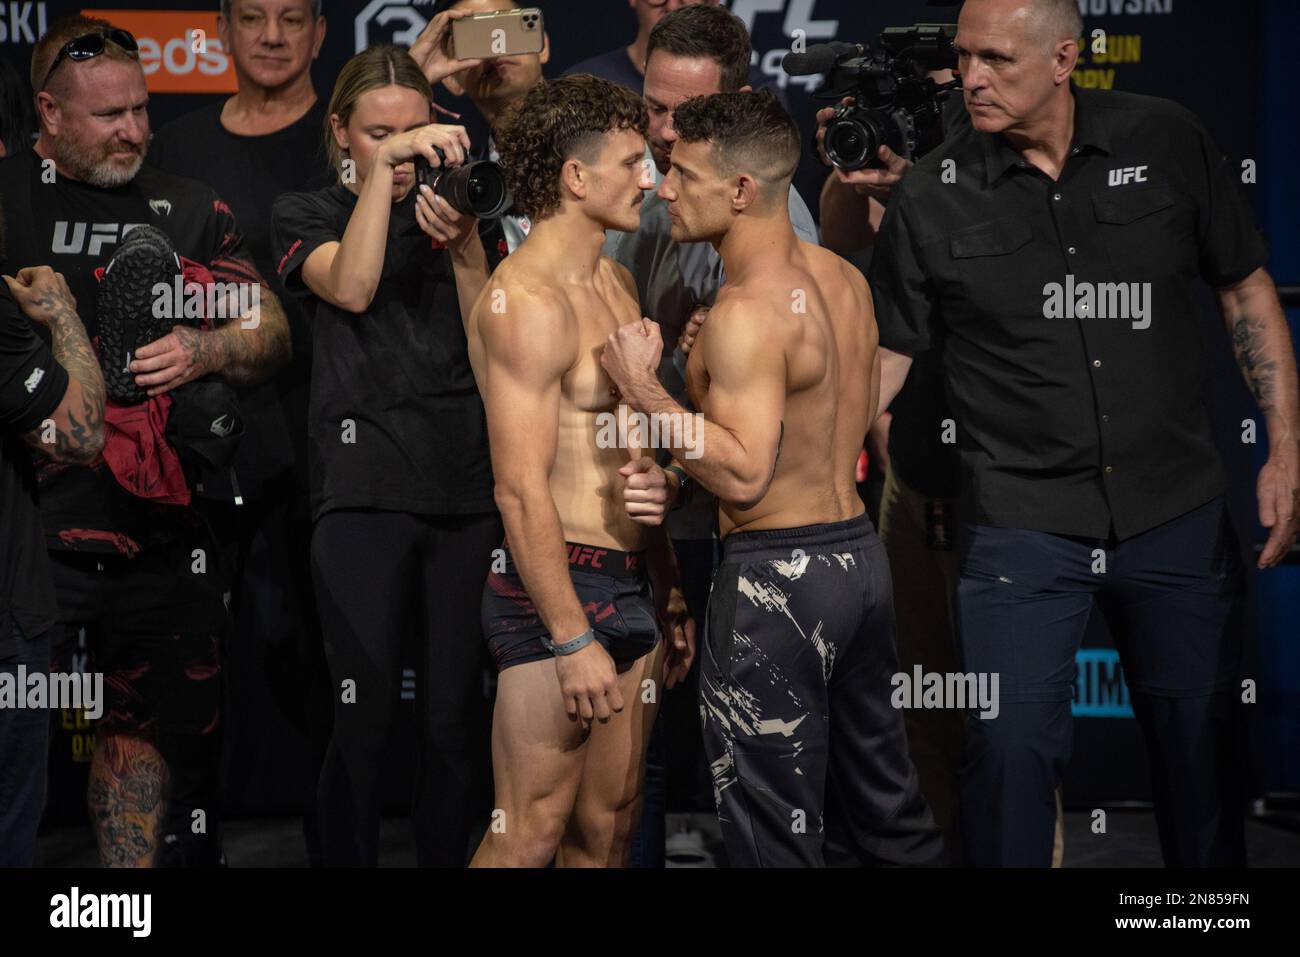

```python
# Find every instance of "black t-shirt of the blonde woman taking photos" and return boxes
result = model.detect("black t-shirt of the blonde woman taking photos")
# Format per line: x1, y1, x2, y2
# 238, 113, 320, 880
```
272, 185, 495, 519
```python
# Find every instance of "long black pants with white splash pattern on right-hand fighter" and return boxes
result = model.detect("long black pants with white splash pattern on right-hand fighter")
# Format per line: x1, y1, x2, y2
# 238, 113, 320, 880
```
699, 515, 944, 867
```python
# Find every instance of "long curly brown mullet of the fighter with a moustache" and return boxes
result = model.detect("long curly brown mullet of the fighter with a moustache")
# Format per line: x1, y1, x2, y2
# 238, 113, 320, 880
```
497, 73, 649, 222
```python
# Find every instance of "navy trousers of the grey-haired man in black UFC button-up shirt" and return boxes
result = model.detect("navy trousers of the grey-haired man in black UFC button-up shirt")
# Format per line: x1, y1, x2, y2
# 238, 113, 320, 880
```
957, 498, 1245, 867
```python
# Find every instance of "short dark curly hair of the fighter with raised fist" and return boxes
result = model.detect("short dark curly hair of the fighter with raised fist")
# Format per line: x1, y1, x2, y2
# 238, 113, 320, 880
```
672, 87, 800, 183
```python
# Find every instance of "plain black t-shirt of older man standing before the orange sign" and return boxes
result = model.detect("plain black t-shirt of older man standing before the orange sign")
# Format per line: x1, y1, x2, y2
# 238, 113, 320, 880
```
148, 100, 334, 498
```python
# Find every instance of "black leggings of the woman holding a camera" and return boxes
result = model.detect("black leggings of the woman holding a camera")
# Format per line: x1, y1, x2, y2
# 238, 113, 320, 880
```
312, 511, 504, 867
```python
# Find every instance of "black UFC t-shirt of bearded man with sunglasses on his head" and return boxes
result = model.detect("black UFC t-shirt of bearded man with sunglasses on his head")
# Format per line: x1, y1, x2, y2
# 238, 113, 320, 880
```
0, 150, 261, 555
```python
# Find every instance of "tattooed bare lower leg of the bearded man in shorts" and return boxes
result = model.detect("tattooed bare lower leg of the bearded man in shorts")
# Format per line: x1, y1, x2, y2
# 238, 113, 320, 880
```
87, 735, 168, 867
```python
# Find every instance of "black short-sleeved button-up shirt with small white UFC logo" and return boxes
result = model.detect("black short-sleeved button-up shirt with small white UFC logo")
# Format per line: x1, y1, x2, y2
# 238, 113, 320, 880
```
870, 88, 1266, 540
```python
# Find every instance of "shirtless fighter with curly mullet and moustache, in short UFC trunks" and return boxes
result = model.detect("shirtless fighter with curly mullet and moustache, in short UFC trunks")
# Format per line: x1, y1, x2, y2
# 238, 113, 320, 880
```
467, 74, 693, 867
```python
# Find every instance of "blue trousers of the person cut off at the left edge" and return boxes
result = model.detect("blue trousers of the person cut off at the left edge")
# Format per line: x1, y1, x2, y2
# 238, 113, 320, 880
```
0, 632, 51, 867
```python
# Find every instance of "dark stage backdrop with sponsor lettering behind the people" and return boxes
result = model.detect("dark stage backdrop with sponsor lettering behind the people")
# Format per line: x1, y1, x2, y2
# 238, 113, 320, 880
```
0, 0, 1300, 811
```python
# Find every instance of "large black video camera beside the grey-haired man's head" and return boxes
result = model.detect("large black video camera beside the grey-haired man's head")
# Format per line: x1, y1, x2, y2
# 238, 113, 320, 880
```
781, 23, 961, 170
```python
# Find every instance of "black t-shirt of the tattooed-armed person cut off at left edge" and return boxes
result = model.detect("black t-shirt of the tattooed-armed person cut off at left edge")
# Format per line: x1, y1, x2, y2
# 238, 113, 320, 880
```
0, 282, 68, 659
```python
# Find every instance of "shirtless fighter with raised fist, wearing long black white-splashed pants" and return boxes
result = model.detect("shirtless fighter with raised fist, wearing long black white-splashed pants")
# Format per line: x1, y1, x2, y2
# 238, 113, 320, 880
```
602, 91, 943, 867
